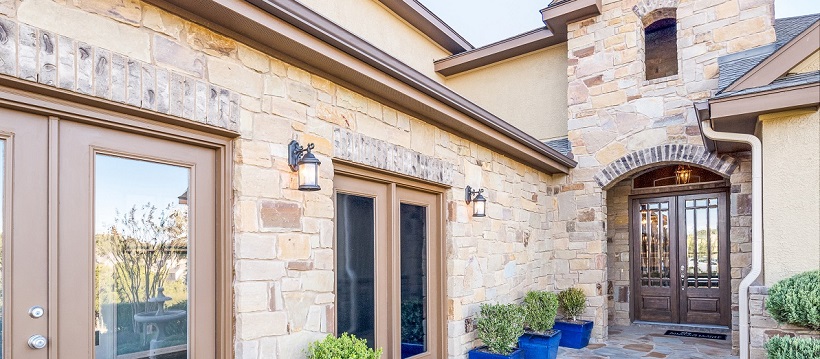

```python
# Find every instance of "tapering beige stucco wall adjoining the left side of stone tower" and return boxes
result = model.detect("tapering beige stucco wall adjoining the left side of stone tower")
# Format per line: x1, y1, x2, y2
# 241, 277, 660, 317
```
446, 44, 567, 141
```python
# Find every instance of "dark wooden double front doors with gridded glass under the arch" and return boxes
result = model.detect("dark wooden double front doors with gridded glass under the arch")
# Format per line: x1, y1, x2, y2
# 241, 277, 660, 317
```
630, 192, 731, 326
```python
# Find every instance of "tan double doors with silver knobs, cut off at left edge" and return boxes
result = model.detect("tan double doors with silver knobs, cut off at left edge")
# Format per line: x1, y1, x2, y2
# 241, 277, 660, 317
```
0, 108, 216, 359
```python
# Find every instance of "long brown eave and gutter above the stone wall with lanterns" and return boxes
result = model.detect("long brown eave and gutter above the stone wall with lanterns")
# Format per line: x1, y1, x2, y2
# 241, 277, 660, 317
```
151, 0, 577, 174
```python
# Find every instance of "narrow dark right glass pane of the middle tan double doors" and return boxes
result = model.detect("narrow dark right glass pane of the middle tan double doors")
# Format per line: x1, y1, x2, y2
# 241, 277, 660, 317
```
400, 203, 427, 358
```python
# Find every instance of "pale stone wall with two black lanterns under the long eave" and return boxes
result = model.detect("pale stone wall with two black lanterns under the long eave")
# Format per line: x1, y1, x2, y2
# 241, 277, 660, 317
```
0, 0, 560, 359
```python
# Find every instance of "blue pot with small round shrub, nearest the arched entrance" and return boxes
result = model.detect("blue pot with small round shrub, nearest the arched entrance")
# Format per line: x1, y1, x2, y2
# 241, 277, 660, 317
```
554, 288, 593, 349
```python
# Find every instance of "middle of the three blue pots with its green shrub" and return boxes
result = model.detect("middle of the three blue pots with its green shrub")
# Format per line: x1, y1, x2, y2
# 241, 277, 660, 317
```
518, 291, 561, 359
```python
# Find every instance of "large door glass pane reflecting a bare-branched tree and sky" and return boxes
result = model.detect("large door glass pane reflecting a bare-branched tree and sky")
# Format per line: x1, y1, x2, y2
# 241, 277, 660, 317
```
94, 155, 190, 359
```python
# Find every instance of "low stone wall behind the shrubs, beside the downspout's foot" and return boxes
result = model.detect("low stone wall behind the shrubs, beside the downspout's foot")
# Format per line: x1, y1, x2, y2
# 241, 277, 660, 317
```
749, 286, 820, 358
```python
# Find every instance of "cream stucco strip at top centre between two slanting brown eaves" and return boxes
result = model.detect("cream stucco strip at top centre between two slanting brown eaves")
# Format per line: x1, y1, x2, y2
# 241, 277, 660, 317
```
300, 0, 450, 82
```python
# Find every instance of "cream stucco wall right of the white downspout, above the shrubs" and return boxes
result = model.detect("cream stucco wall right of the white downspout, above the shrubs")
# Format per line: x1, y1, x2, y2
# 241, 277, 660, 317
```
760, 110, 820, 286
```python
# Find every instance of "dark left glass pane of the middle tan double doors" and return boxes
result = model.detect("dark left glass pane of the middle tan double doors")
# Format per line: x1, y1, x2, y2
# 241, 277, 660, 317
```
336, 193, 376, 348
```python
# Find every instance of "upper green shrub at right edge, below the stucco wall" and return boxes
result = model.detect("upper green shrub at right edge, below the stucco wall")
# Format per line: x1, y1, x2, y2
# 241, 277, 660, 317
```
766, 270, 820, 330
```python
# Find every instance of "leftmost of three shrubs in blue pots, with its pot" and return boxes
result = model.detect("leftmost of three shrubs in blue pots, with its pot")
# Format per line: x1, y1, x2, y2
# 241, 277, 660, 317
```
469, 304, 524, 359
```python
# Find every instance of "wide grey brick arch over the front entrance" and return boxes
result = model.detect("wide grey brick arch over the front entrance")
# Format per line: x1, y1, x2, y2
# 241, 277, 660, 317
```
594, 144, 738, 190
